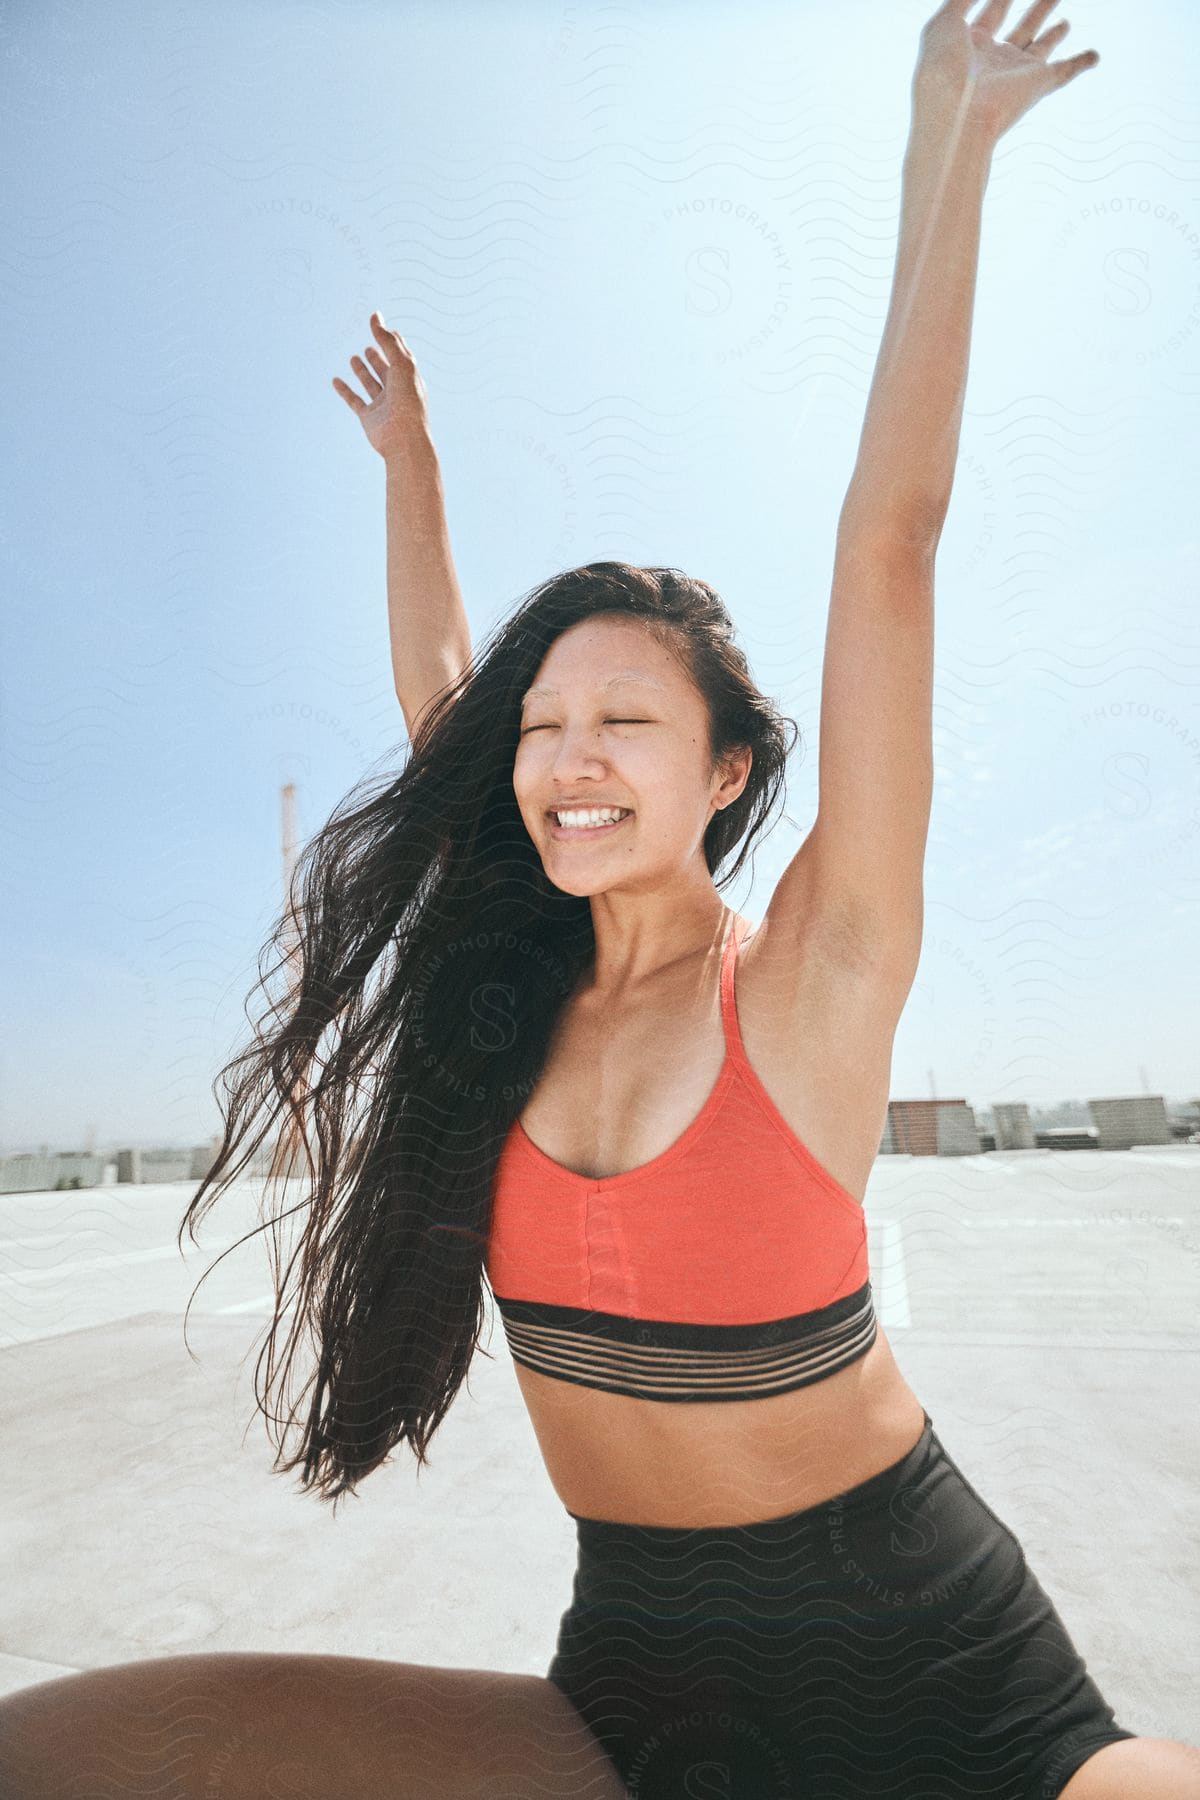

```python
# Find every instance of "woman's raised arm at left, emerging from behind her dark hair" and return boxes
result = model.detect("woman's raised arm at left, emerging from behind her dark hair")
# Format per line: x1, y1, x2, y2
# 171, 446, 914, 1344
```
333, 313, 471, 738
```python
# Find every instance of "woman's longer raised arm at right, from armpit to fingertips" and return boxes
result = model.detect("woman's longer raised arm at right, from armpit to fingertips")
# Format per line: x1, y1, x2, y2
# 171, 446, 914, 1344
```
765, 0, 1099, 992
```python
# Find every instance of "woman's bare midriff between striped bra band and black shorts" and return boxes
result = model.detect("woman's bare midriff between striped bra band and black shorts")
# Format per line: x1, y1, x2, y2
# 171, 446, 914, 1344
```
513, 1328, 925, 1526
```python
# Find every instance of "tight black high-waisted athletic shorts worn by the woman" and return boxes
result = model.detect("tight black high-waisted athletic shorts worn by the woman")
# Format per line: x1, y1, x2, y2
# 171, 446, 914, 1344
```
547, 1413, 1137, 1800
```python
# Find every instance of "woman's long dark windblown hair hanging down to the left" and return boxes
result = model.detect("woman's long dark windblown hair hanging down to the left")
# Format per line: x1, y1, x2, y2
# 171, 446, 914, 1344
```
178, 562, 797, 1512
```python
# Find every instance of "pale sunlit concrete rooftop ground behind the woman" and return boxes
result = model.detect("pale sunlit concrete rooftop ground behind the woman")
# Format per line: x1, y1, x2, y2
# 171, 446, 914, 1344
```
0, 1145, 1200, 1742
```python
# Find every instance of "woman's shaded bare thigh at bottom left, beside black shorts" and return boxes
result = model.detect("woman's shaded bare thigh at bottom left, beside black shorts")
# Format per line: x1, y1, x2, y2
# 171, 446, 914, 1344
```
0, 1651, 628, 1800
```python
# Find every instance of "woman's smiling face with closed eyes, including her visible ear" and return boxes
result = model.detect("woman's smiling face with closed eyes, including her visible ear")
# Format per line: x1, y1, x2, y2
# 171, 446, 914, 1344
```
513, 614, 750, 895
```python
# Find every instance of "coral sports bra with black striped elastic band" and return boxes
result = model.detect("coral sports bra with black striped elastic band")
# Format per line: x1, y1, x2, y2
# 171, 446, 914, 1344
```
486, 922, 876, 1400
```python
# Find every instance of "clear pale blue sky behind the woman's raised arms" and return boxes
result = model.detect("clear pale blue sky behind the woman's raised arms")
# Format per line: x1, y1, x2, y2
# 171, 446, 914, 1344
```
0, 0, 1200, 1150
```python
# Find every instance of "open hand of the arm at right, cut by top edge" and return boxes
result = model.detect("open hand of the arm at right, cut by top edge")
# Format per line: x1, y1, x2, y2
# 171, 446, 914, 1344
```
912, 0, 1099, 142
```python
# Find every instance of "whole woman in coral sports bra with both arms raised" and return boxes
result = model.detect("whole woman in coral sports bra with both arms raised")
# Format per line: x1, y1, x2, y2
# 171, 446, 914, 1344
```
0, 0, 1200, 1800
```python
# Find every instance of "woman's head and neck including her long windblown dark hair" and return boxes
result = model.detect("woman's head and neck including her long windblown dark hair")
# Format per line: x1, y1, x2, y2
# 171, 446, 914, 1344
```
185, 562, 795, 1508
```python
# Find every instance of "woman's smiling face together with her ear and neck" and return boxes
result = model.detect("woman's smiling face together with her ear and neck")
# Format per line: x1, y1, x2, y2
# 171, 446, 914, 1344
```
513, 616, 750, 994
